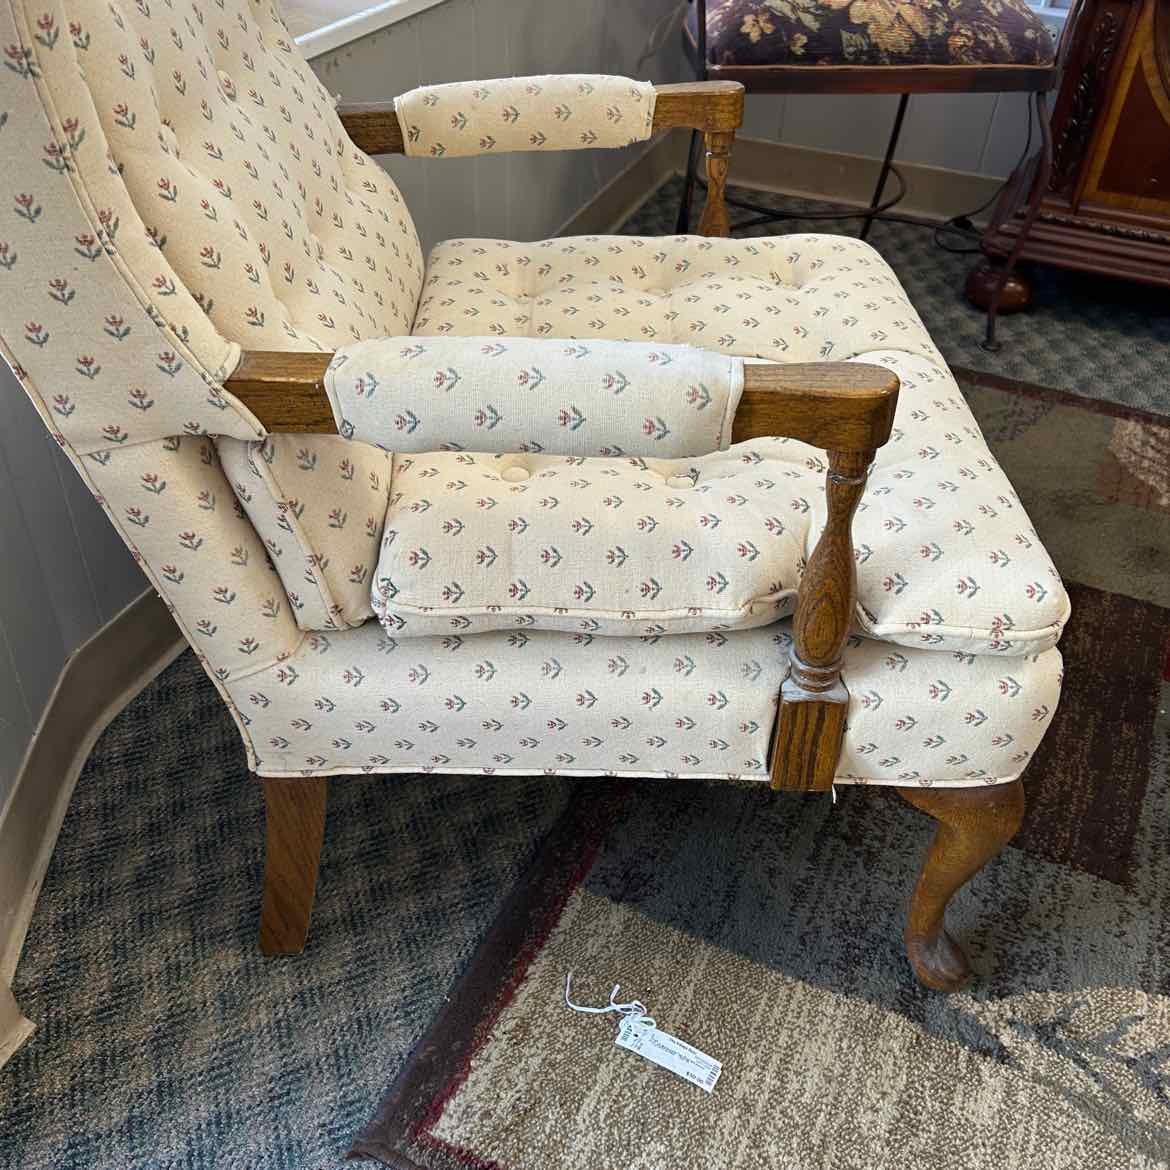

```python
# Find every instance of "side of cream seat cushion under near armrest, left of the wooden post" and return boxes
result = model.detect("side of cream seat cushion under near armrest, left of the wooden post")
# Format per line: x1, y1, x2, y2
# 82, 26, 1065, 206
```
372, 452, 806, 636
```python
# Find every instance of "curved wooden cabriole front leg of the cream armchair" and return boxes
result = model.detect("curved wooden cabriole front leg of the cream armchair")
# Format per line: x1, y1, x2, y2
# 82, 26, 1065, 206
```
897, 780, 1024, 991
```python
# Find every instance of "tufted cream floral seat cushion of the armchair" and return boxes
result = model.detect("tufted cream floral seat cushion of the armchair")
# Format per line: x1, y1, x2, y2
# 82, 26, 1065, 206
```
409, 235, 1068, 655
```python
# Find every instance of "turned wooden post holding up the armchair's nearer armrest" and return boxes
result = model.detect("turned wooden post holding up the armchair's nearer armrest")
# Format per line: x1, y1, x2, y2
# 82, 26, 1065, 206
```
772, 450, 874, 791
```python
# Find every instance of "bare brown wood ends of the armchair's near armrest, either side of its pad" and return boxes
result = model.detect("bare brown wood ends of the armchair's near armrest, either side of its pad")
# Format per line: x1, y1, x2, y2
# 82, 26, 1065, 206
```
225, 350, 899, 452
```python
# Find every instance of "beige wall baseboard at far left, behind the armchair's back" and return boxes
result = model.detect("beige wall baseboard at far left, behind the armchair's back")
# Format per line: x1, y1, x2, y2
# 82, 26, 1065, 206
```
0, 590, 187, 987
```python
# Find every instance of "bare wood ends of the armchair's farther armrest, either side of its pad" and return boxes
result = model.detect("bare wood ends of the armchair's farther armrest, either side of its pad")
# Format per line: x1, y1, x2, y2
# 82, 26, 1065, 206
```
337, 81, 744, 154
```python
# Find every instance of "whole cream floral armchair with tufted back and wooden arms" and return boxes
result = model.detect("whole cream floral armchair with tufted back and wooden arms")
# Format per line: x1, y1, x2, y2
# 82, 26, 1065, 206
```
0, 0, 1068, 989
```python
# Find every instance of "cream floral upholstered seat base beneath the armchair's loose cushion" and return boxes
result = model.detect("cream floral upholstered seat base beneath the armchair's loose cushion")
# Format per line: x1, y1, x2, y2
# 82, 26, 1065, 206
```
228, 622, 1061, 785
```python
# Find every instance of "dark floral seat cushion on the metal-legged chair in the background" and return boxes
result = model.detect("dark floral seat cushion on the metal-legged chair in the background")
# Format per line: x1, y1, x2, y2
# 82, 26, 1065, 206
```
687, 0, 1055, 67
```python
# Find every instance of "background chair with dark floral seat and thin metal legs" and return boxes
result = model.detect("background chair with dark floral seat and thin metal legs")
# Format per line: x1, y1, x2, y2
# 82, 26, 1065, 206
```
679, 0, 1075, 349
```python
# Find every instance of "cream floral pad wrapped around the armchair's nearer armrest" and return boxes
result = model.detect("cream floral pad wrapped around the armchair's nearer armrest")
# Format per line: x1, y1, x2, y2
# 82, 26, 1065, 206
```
324, 337, 743, 459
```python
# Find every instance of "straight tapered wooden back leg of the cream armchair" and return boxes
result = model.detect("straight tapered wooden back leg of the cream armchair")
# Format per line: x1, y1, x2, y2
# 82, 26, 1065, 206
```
260, 777, 329, 955
